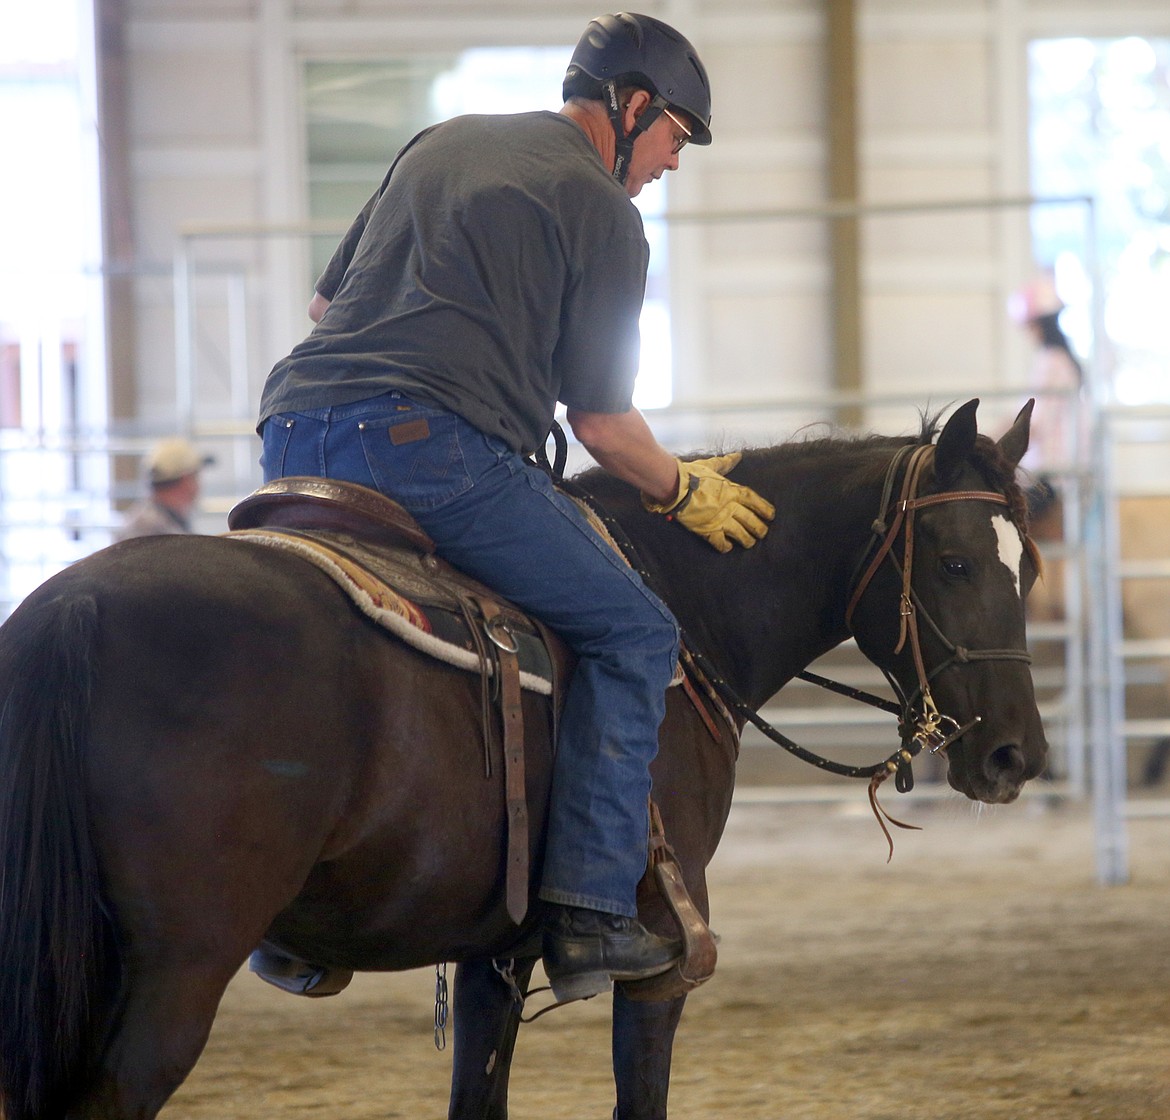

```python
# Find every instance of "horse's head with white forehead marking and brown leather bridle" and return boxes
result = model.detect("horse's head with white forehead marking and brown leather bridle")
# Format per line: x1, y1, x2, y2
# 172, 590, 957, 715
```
849, 400, 1047, 803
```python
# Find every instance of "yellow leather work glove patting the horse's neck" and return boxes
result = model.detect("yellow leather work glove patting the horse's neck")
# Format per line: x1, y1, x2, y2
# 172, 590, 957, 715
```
642, 452, 776, 552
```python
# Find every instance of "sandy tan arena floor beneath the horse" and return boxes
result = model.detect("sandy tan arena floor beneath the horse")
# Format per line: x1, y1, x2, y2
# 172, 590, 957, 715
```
163, 791, 1170, 1120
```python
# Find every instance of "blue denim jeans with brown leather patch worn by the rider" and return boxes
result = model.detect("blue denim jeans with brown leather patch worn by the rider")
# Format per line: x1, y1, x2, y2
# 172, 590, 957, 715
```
261, 392, 679, 916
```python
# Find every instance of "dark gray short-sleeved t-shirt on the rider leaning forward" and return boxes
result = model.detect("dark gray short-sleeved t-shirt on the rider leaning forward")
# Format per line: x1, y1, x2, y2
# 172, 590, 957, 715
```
260, 112, 649, 452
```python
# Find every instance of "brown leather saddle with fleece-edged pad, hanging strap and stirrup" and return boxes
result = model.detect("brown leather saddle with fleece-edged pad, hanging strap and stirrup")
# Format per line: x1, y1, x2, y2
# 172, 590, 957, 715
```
227, 477, 720, 999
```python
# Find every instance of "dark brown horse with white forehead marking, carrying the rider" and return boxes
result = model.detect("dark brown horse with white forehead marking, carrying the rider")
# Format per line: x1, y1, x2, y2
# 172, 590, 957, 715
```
0, 401, 1046, 1120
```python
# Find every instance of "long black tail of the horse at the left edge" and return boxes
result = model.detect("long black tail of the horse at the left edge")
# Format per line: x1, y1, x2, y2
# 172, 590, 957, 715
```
0, 597, 117, 1120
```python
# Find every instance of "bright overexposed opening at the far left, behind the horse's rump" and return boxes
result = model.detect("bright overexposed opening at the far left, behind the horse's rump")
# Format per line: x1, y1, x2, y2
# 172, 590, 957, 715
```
0, 0, 111, 614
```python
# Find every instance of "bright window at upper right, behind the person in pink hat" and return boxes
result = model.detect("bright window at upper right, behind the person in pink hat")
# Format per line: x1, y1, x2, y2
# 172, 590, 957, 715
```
1030, 37, 1170, 404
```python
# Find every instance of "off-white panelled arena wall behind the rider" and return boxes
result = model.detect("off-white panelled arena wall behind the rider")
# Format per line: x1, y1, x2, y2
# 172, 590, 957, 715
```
114, 0, 1170, 463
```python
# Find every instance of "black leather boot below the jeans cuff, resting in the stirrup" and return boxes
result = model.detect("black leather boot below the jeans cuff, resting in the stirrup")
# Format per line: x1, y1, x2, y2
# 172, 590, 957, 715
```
544, 906, 682, 1003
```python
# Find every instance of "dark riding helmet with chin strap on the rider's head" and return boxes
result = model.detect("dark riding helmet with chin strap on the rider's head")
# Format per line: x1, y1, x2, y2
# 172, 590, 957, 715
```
563, 12, 711, 183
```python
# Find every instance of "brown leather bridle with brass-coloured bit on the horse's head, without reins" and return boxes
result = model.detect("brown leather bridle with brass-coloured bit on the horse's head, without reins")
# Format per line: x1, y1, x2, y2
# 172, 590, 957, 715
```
845, 445, 1038, 791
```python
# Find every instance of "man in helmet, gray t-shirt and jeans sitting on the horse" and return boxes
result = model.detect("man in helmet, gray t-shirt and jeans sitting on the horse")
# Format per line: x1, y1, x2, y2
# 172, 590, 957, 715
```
253, 13, 773, 999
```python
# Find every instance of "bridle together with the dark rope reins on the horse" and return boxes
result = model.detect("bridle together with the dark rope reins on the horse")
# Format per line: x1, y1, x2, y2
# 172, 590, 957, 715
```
545, 437, 1034, 857
